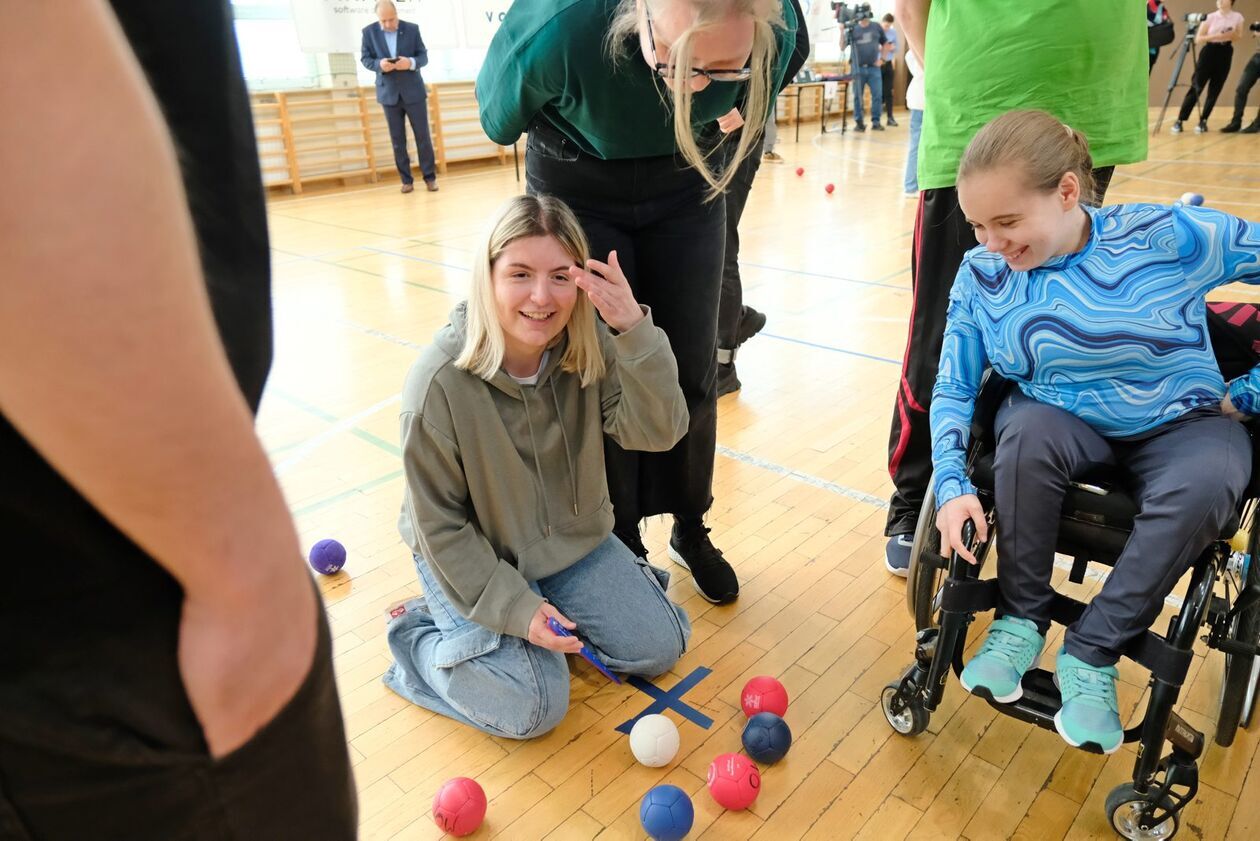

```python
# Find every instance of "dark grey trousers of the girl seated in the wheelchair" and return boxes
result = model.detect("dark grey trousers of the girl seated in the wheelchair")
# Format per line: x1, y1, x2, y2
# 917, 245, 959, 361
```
993, 388, 1251, 667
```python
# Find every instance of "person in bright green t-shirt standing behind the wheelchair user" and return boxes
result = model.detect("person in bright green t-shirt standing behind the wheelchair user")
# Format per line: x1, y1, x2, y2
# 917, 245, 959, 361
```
885, 0, 1148, 576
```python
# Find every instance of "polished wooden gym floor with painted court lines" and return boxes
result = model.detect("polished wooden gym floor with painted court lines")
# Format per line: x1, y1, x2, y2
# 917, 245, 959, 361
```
260, 112, 1260, 841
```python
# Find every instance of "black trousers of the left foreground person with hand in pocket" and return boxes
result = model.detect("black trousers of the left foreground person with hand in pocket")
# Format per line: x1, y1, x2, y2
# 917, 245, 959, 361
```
0, 581, 358, 841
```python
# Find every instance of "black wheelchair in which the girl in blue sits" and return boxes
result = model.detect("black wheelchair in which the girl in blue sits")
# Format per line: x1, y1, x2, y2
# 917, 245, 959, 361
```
881, 360, 1260, 838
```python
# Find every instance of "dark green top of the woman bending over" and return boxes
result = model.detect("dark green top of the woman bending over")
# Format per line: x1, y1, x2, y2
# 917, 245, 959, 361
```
476, 0, 804, 160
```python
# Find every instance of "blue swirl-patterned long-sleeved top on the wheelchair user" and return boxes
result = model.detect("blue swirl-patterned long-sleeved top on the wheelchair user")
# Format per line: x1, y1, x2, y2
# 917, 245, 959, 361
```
931, 204, 1260, 504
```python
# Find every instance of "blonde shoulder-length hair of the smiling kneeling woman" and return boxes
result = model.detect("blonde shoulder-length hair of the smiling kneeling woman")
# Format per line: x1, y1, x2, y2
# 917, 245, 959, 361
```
455, 195, 604, 387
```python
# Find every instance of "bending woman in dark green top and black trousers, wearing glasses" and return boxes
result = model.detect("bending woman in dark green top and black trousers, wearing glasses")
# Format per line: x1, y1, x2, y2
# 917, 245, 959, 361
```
476, 0, 804, 604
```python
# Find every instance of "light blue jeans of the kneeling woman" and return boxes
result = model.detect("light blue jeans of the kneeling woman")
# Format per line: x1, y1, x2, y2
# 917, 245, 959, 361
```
384, 535, 692, 739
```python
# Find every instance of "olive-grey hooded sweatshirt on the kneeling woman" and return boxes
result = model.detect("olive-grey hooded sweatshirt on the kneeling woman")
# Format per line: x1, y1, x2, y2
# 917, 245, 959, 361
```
398, 304, 688, 638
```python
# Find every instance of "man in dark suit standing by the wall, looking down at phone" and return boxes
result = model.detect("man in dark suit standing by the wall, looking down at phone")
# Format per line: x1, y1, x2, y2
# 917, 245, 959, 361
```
362, 0, 437, 193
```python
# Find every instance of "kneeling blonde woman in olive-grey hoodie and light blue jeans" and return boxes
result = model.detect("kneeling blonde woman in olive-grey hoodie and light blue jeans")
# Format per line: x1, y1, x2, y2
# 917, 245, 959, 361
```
384, 195, 690, 739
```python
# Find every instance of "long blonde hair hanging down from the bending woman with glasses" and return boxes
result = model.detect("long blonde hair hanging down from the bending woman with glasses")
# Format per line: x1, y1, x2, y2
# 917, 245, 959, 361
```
605, 0, 781, 200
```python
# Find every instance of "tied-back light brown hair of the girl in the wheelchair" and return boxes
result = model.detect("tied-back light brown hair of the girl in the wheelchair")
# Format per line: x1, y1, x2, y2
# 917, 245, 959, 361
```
958, 110, 1099, 204
